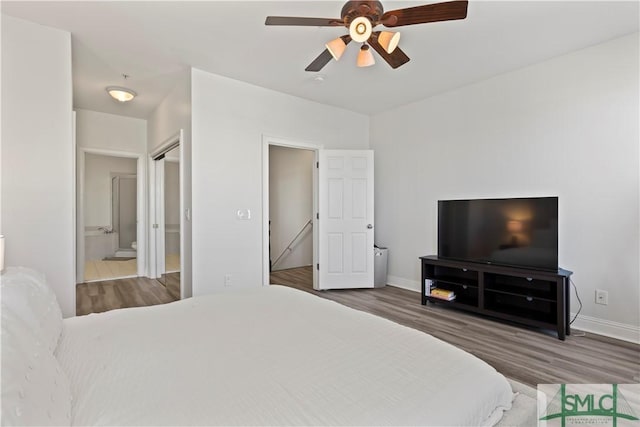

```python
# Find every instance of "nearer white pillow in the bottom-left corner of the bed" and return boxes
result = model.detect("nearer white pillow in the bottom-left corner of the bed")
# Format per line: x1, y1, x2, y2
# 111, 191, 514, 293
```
1, 307, 71, 426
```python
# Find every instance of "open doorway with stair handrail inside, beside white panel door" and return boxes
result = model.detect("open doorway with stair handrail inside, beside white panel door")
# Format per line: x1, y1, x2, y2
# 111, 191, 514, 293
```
263, 138, 319, 290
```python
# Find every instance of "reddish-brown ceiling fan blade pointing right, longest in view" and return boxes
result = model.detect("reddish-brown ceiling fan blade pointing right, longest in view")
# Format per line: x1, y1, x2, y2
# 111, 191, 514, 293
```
380, 0, 469, 27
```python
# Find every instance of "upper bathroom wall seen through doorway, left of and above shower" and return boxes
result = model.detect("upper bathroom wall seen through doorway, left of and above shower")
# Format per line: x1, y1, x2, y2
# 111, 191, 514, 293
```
84, 153, 137, 228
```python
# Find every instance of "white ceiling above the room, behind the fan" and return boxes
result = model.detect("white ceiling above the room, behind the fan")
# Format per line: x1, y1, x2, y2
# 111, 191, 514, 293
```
1, 0, 639, 118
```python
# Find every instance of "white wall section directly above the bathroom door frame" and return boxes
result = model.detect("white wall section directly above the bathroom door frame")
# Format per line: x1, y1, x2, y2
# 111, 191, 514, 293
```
76, 108, 147, 154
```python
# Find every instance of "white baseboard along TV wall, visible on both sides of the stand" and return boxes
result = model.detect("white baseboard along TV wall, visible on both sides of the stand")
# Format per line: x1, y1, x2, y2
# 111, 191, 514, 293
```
387, 276, 640, 344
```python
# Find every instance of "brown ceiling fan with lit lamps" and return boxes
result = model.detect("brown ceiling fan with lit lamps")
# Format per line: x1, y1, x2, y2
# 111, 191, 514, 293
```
265, 0, 468, 72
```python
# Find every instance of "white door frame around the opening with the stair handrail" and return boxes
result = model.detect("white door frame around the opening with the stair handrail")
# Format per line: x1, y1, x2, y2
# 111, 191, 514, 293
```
262, 135, 324, 289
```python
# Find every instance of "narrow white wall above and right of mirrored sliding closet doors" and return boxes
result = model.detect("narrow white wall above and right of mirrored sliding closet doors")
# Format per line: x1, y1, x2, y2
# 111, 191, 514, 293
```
147, 70, 192, 298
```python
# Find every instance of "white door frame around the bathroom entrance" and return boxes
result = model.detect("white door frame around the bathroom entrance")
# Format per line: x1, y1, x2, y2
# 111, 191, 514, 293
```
76, 147, 147, 283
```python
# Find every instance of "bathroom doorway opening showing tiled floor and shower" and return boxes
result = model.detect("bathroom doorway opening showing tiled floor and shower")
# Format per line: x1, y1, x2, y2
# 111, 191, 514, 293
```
77, 150, 143, 283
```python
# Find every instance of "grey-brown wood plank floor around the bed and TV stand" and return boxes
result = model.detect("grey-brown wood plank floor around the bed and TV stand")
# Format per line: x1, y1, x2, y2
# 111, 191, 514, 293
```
76, 267, 640, 387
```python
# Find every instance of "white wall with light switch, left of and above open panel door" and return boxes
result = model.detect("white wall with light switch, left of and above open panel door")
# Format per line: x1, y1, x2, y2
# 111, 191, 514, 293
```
192, 69, 369, 295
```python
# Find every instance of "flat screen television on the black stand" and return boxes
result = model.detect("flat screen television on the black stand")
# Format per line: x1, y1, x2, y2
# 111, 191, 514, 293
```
438, 197, 558, 271
